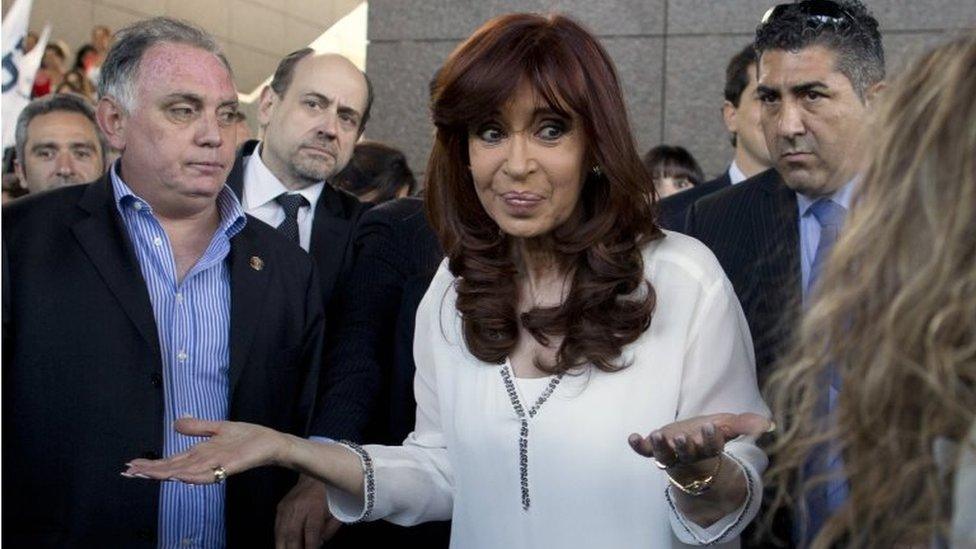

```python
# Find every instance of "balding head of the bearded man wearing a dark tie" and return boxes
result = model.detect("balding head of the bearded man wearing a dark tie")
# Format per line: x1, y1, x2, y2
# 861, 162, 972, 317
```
258, 49, 372, 190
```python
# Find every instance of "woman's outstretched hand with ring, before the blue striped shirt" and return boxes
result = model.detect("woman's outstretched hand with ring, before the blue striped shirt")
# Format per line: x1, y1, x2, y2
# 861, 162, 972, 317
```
122, 418, 290, 484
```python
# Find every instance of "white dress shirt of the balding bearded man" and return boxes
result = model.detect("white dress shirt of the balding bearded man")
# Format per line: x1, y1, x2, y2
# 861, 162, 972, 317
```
241, 143, 325, 252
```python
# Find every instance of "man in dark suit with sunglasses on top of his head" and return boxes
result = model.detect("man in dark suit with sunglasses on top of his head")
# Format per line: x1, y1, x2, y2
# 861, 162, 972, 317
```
687, 0, 885, 545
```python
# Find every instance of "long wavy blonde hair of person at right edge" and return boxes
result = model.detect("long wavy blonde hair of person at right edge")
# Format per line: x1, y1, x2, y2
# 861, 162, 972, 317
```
767, 33, 976, 548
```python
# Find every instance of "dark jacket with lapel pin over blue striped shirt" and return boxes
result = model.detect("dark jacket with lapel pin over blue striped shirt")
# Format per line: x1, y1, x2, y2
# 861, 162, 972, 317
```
3, 176, 323, 547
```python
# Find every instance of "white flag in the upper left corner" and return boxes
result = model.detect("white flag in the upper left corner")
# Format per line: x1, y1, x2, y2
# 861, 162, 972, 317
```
2, 0, 51, 149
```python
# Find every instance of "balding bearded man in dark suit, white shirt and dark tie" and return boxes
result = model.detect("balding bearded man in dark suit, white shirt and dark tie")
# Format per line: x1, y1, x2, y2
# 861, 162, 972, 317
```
227, 48, 380, 546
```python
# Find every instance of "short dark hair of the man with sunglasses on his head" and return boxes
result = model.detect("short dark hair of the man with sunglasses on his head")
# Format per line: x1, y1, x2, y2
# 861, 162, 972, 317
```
755, 0, 885, 100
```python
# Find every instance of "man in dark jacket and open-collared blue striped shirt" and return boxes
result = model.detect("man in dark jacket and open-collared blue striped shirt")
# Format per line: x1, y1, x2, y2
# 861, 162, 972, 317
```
3, 18, 323, 548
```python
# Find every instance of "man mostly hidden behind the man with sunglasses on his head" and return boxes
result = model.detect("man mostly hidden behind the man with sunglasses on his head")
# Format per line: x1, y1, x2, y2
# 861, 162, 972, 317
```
658, 43, 771, 232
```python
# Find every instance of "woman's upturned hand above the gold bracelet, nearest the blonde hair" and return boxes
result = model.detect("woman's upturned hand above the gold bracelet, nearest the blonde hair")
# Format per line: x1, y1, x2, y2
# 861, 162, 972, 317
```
627, 413, 773, 478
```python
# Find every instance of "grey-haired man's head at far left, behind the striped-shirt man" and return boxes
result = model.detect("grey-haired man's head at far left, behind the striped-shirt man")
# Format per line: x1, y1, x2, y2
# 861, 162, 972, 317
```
14, 94, 107, 193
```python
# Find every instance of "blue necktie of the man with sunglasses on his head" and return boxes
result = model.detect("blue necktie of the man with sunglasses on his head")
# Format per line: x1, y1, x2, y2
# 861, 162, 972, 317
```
802, 198, 848, 546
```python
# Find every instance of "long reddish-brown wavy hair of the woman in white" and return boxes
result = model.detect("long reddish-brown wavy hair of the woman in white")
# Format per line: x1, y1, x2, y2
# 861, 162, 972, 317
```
426, 14, 663, 373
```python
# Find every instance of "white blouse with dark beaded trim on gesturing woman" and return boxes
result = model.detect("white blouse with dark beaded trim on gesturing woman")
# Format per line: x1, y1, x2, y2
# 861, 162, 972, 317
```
329, 232, 769, 549
